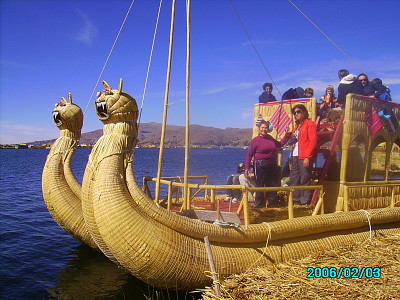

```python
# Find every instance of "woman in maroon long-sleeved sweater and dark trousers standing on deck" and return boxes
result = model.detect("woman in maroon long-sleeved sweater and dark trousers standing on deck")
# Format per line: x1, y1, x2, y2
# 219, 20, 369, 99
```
245, 120, 288, 208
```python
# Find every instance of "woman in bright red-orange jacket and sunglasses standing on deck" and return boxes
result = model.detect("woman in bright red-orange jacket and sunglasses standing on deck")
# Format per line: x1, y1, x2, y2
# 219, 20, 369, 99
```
289, 104, 317, 205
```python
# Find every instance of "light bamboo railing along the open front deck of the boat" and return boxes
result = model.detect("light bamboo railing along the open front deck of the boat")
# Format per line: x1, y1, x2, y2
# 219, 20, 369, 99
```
143, 176, 324, 225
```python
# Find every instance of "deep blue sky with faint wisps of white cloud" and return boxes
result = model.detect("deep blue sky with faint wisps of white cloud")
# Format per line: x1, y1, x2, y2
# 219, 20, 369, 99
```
0, 0, 400, 144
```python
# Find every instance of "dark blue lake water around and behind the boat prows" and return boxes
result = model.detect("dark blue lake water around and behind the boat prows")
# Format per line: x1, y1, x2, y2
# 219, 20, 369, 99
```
0, 149, 250, 299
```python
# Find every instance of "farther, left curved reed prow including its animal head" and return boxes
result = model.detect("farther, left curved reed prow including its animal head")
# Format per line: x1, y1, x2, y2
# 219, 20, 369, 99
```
42, 94, 98, 249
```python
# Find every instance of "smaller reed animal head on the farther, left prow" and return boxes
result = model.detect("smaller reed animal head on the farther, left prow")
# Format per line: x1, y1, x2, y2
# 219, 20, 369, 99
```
53, 93, 83, 130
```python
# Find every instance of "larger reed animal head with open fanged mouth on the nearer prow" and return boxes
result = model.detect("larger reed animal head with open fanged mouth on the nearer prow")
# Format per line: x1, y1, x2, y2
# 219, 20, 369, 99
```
94, 79, 138, 124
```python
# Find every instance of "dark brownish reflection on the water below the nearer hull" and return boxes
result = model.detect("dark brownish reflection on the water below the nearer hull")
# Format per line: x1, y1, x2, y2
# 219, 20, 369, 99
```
47, 245, 200, 299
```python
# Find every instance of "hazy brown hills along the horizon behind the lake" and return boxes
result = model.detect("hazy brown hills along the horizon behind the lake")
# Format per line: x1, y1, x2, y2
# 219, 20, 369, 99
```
28, 123, 253, 147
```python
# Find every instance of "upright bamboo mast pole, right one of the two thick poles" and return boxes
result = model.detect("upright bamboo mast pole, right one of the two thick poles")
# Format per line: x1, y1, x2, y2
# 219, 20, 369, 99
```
183, 0, 190, 207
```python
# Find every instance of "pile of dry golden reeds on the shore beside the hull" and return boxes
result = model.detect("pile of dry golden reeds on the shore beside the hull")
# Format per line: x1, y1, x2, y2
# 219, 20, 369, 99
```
202, 235, 400, 300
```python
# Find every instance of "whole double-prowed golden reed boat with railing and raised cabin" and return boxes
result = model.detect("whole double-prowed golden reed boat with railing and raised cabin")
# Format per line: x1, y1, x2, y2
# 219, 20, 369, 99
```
43, 0, 400, 290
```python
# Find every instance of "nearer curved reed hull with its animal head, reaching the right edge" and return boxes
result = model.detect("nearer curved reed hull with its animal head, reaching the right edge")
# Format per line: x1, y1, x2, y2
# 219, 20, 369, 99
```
82, 81, 400, 289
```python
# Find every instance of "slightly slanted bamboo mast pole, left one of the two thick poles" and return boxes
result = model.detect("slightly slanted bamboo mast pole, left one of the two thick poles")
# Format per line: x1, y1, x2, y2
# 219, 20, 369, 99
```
155, 0, 176, 203
